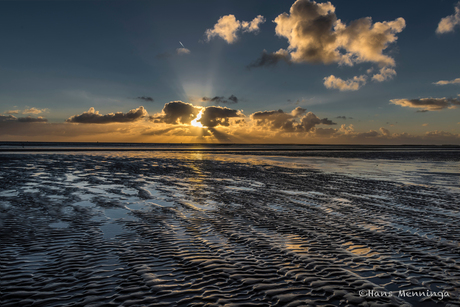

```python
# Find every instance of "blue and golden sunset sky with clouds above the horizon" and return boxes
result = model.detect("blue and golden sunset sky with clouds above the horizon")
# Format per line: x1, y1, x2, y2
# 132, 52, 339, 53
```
0, 0, 460, 144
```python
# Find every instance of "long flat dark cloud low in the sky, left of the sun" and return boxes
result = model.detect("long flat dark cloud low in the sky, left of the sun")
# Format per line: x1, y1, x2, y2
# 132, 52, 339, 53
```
66, 106, 148, 124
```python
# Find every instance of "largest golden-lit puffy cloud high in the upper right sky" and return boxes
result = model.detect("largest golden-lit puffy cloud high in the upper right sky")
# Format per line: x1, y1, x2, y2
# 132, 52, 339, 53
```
255, 0, 406, 67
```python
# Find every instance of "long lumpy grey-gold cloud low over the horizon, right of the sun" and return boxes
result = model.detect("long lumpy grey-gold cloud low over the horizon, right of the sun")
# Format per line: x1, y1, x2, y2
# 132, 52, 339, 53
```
251, 107, 335, 132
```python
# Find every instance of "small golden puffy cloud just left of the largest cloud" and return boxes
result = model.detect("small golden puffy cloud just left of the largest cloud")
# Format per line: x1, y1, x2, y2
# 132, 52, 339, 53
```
205, 14, 265, 44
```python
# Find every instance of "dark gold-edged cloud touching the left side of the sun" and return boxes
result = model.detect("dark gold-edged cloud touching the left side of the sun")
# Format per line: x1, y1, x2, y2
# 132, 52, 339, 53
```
150, 101, 201, 125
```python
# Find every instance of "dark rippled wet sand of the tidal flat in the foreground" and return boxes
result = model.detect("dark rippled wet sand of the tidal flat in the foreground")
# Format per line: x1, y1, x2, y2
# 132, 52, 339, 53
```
0, 153, 460, 307
